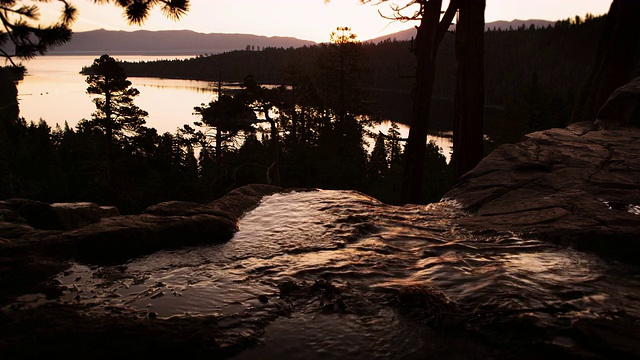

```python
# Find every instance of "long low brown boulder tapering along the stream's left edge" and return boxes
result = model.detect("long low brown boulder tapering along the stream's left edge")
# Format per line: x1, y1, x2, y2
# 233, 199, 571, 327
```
45, 185, 282, 264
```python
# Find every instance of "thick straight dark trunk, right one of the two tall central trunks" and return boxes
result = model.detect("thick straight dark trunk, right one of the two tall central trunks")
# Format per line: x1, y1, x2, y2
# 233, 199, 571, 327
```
452, 0, 486, 179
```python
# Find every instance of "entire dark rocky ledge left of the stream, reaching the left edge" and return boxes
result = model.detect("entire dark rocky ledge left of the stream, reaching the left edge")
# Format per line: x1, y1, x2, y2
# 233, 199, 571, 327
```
0, 185, 282, 303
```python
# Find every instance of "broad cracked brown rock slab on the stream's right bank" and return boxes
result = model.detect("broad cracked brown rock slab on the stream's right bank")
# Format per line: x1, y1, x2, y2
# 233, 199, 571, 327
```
445, 123, 640, 264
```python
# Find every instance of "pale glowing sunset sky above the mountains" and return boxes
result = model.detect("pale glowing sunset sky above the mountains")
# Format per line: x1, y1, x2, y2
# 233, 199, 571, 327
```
36, 0, 611, 42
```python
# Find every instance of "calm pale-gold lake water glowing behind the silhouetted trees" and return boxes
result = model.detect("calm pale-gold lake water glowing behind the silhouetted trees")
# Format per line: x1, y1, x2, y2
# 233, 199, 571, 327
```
18, 55, 453, 159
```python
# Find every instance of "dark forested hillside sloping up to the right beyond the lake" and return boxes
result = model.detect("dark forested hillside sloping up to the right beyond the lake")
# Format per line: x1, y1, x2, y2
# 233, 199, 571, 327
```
123, 15, 604, 150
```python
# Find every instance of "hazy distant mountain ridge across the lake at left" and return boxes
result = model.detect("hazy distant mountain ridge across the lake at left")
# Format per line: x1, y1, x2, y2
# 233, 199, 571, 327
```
51, 29, 316, 55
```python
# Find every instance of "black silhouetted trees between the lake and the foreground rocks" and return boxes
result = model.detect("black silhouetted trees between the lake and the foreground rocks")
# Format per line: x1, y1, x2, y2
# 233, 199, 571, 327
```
0, 45, 448, 213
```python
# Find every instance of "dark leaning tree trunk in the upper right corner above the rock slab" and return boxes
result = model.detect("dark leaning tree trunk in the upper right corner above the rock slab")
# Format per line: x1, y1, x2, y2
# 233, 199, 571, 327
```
571, 0, 640, 122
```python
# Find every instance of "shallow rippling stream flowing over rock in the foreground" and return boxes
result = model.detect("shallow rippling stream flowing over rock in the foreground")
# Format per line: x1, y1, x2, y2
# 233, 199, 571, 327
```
11, 191, 640, 359
